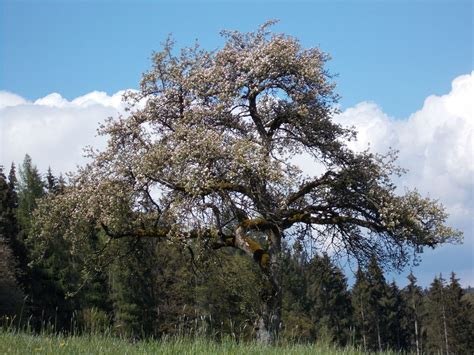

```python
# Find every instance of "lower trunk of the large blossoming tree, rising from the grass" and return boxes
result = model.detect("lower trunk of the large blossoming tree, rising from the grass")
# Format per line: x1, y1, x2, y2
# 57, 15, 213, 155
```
255, 231, 282, 344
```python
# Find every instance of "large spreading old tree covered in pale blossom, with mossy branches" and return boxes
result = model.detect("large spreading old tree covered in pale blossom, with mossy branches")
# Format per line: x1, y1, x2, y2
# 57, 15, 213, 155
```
31, 22, 460, 342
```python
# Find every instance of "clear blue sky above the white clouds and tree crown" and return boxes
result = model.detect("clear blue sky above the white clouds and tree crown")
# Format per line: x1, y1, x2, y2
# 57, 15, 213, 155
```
0, 0, 473, 118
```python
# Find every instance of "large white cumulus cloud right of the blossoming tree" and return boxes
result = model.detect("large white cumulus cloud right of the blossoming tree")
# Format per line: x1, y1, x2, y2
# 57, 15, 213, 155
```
336, 72, 474, 285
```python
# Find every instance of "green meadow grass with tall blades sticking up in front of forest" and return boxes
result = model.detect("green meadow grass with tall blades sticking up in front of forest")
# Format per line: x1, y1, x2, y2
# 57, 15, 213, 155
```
0, 312, 404, 355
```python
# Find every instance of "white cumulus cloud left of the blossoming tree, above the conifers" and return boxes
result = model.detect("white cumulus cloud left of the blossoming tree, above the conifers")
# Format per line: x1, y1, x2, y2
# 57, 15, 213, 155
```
0, 91, 133, 173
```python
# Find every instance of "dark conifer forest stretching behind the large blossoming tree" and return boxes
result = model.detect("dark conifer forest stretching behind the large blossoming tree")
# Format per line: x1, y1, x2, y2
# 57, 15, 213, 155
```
0, 156, 474, 354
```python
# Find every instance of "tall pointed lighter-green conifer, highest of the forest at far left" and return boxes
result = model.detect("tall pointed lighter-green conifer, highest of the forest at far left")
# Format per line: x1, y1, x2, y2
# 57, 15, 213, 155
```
16, 155, 79, 330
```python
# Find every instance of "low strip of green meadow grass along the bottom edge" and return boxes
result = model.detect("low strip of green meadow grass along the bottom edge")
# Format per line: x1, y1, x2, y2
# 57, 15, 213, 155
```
0, 331, 391, 355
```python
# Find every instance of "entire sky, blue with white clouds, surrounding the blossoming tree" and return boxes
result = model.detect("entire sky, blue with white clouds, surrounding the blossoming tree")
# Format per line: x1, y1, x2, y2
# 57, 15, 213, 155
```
0, 0, 474, 286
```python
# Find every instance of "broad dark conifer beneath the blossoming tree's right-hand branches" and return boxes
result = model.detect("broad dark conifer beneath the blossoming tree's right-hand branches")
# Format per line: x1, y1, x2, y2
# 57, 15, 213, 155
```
308, 254, 352, 345
